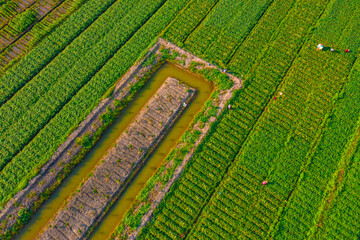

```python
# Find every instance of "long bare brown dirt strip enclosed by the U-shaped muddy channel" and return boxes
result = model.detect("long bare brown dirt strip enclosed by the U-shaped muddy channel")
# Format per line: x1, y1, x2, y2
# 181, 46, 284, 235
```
40, 78, 195, 240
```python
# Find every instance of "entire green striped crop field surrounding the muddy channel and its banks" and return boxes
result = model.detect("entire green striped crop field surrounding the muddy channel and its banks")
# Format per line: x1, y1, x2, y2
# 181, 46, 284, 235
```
0, 0, 360, 240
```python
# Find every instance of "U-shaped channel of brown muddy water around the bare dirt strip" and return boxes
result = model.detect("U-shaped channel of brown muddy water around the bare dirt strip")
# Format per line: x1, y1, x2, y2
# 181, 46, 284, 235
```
16, 64, 214, 240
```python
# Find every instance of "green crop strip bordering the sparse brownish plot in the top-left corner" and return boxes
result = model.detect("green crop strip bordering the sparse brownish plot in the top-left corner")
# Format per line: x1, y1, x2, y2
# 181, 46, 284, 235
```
0, 0, 115, 106
